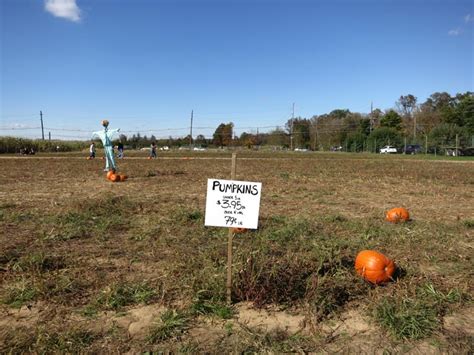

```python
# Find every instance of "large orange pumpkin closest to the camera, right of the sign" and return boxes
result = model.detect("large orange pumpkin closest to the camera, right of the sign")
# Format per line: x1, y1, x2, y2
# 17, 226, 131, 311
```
355, 250, 395, 284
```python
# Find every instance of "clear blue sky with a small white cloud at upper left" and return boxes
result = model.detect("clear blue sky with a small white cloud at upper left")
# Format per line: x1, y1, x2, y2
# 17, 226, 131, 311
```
0, 0, 474, 139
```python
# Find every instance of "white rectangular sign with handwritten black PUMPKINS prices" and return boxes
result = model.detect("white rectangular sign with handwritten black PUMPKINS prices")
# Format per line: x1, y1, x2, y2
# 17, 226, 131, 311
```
204, 179, 262, 229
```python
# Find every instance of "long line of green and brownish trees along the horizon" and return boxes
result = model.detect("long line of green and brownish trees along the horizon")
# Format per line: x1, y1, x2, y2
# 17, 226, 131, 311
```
121, 91, 474, 152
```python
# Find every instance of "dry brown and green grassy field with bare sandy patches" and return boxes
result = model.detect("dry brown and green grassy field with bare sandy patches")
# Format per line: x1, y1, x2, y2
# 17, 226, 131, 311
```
0, 152, 474, 354
